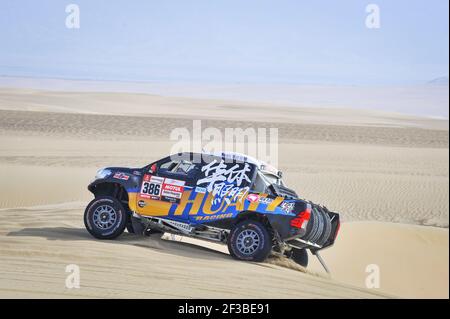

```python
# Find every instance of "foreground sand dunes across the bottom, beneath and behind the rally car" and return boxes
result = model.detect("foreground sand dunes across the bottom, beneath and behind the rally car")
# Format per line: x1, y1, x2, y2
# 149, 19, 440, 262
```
0, 203, 448, 298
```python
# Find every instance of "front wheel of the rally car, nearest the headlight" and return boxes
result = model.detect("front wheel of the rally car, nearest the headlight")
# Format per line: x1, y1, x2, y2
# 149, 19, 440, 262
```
84, 196, 128, 239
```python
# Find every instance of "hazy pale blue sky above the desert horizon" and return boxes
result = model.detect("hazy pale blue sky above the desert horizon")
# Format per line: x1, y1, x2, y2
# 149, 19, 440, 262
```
0, 0, 449, 84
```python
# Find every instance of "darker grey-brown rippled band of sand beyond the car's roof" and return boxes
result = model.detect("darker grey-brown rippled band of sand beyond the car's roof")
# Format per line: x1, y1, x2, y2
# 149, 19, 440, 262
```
0, 111, 448, 148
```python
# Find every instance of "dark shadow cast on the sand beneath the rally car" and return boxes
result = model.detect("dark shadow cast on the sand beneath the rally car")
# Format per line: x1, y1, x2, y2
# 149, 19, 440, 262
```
7, 227, 231, 259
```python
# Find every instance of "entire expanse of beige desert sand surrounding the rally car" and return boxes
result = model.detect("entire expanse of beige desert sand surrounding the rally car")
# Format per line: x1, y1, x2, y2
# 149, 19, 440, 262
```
0, 88, 449, 298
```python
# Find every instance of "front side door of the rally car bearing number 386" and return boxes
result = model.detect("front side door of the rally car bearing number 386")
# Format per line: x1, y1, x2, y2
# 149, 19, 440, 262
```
136, 158, 198, 220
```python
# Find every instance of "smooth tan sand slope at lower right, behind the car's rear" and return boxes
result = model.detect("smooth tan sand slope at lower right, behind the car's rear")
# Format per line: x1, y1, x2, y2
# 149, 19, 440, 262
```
310, 222, 449, 298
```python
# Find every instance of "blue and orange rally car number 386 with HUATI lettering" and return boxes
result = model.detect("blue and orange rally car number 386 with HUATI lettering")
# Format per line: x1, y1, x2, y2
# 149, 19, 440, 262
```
84, 153, 340, 270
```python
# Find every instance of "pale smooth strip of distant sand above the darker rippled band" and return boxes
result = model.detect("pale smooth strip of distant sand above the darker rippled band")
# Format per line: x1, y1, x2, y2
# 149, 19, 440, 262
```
0, 87, 448, 131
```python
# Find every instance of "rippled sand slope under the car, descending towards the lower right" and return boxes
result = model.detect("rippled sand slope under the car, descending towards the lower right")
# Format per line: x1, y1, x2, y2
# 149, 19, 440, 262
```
0, 205, 390, 298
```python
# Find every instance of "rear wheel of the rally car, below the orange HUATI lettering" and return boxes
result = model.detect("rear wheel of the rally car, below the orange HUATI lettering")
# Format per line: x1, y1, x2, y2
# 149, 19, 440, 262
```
228, 220, 272, 262
